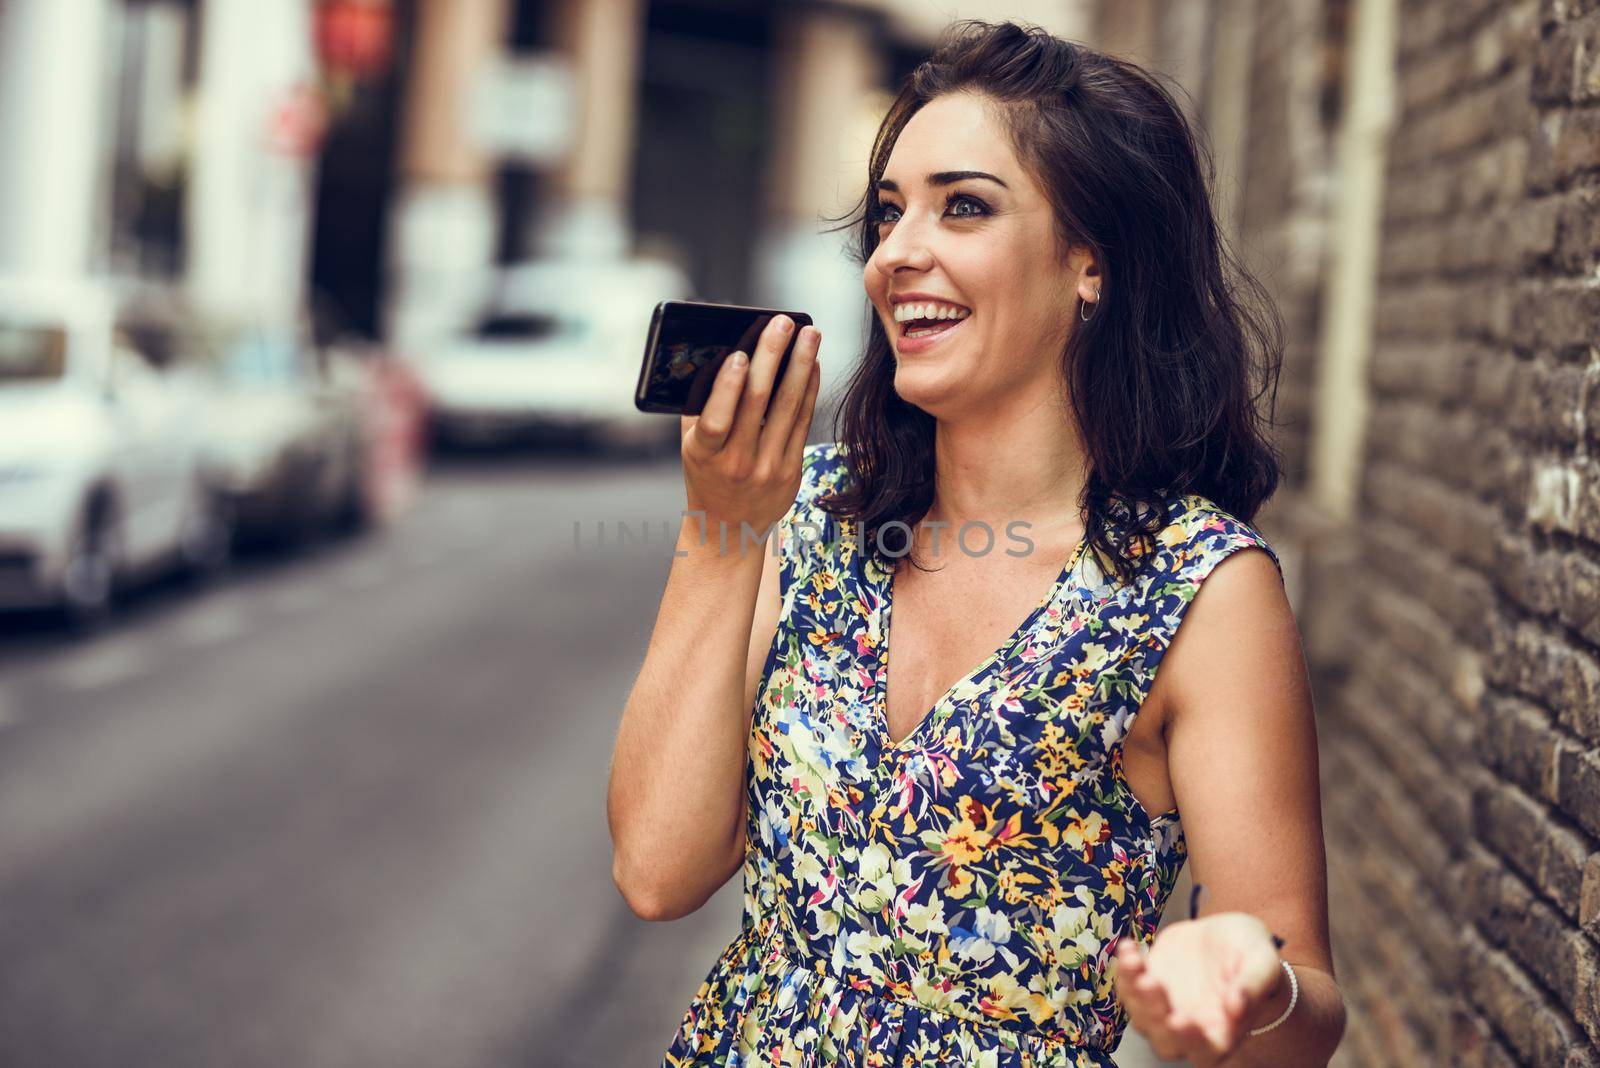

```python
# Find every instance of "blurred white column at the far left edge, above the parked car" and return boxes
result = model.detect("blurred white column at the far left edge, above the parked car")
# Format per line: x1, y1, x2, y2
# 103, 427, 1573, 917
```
0, 0, 110, 277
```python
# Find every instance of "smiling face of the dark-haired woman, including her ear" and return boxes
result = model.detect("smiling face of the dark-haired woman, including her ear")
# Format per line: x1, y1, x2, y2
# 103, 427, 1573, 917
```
862, 93, 1099, 419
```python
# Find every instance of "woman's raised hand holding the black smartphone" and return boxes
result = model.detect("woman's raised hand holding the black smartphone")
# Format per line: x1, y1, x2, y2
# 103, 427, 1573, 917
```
680, 315, 822, 545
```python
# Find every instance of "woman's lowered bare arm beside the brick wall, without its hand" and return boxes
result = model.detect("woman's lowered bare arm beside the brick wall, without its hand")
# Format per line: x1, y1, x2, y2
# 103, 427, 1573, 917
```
1152, 550, 1346, 1068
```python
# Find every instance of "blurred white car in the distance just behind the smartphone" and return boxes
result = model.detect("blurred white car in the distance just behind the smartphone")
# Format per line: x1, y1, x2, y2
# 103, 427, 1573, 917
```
416, 259, 691, 448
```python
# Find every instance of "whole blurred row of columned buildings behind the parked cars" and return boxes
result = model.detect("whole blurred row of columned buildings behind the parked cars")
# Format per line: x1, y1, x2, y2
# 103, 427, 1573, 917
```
0, 0, 1088, 422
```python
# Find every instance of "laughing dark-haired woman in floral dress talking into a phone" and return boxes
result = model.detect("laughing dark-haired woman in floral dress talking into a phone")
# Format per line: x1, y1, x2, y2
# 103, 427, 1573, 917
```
610, 22, 1344, 1068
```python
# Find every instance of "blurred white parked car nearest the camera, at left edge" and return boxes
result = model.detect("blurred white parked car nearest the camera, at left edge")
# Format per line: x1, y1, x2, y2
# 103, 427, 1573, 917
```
0, 281, 230, 624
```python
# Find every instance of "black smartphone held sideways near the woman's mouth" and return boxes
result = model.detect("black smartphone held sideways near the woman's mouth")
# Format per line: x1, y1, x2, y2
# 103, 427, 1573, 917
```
634, 301, 813, 416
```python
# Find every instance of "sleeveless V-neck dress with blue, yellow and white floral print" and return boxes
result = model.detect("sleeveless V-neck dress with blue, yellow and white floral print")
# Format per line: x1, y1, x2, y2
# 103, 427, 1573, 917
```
662, 443, 1282, 1068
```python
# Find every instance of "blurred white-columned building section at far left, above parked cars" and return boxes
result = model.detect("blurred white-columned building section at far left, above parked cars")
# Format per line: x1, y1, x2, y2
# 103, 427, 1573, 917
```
0, 0, 366, 334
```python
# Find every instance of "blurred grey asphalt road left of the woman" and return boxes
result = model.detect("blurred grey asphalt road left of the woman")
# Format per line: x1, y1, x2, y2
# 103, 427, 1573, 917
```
0, 454, 1142, 1068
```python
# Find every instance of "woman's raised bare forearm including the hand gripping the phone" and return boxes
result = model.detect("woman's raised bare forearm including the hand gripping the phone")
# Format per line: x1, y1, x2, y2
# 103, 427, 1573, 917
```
606, 320, 819, 919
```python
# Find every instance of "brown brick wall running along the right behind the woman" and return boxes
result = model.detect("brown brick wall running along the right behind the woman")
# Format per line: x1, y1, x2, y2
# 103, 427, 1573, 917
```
1245, 0, 1600, 1068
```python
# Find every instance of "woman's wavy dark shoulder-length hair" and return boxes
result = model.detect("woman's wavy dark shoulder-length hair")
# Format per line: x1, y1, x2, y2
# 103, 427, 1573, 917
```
822, 19, 1283, 580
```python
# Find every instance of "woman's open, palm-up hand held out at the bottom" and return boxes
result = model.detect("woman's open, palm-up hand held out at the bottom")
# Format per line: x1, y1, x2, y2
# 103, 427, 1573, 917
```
1117, 913, 1288, 1068
